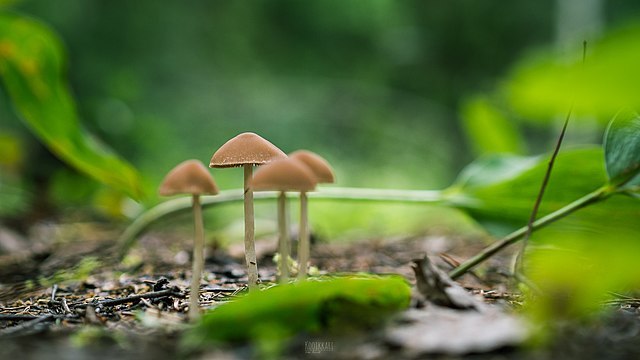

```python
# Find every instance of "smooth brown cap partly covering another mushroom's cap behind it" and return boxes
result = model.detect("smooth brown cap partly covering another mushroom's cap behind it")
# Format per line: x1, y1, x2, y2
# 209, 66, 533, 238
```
249, 159, 318, 191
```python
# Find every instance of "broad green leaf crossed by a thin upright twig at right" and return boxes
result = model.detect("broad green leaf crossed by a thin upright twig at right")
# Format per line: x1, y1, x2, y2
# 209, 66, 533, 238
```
445, 147, 608, 230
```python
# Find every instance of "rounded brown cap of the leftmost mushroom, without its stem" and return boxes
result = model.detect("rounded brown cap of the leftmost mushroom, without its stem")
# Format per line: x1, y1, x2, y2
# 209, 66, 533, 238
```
158, 160, 218, 196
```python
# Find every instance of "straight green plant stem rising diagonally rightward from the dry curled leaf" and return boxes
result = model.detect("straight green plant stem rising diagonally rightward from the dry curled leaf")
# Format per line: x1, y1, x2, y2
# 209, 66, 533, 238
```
449, 186, 613, 279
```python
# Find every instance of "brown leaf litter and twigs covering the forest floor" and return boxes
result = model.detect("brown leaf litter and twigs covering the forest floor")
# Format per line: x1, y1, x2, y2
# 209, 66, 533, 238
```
0, 224, 640, 359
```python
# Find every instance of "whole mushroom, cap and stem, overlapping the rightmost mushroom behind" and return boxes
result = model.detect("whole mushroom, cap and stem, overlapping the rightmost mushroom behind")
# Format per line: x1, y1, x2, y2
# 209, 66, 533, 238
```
250, 159, 318, 283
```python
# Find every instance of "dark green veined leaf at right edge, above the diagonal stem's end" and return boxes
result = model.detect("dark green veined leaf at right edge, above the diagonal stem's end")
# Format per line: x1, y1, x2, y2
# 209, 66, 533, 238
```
603, 110, 640, 186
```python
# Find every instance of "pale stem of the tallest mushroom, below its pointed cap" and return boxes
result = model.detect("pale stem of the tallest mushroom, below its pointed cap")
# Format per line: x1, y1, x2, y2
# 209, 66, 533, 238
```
244, 164, 258, 291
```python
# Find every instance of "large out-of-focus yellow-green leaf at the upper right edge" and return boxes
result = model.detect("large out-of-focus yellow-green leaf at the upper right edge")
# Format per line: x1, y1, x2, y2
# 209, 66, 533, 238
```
503, 22, 640, 121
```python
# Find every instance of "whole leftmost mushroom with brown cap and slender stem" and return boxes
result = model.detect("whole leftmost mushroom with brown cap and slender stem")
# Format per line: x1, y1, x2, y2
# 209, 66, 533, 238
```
158, 160, 218, 321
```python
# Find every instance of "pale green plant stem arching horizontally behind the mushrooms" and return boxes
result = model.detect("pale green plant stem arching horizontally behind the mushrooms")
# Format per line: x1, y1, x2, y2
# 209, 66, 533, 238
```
118, 187, 446, 259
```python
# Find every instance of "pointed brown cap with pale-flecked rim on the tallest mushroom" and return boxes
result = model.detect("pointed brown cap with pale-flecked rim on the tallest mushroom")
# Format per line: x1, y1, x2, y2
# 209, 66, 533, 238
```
209, 132, 287, 168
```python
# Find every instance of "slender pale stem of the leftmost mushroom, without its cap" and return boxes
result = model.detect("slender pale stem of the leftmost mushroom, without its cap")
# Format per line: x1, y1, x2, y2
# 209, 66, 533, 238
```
189, 194, 204, 321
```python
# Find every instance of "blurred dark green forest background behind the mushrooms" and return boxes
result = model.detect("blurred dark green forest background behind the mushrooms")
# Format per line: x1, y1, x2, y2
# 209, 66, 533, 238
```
0, 0, 640, 239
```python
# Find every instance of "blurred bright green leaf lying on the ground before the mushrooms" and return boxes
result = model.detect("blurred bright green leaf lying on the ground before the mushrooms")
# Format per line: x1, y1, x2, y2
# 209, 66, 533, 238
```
183, 276, 410, 349
